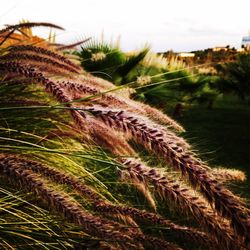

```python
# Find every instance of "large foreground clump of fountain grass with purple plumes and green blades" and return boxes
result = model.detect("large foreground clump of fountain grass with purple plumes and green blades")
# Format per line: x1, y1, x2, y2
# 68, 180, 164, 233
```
0, 23, 249, 250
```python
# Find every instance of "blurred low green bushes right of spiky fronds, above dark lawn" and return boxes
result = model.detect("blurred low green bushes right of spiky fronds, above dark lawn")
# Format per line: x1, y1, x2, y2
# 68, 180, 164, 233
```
134, 64, 219, 110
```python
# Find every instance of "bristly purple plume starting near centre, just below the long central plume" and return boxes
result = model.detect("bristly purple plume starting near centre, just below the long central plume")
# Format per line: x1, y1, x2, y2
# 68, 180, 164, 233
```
120, 160, 241, 249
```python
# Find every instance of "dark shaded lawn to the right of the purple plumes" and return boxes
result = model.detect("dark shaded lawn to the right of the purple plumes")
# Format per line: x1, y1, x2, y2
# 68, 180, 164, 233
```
178, 94, 250, 204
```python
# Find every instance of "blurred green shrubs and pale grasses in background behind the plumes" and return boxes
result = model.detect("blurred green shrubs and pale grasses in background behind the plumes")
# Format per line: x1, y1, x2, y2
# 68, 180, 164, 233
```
77, 41, 218, 109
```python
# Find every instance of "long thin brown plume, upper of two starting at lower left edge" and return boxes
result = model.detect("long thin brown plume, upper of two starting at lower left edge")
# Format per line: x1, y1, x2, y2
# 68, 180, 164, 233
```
0, 154, 215, 249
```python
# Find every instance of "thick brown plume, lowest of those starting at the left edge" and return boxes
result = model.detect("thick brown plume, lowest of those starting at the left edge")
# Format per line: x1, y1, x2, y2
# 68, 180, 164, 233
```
0, 155, 142, 249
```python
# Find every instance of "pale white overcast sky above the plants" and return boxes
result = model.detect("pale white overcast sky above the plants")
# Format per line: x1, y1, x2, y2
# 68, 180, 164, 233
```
0, 0, 250, 52
